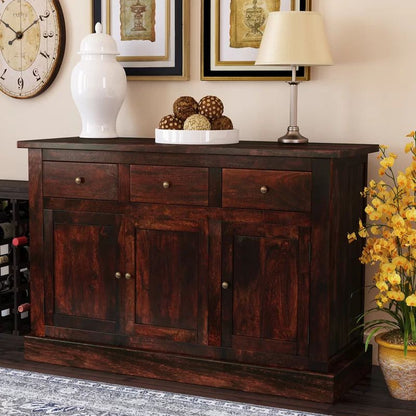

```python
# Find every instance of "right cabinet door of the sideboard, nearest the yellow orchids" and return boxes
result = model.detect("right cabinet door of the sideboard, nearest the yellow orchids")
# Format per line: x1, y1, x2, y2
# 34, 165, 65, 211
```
222, 223, 310, 355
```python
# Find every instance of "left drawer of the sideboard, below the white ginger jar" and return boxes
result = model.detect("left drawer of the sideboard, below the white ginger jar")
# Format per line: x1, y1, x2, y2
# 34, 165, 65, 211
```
43, 162, 118, 201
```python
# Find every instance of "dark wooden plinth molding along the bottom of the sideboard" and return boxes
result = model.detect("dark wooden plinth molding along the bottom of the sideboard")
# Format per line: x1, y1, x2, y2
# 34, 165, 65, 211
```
25, 336, 371, 403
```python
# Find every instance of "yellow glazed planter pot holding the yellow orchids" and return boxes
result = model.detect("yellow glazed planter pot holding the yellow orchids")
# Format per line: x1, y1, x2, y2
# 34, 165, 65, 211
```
375, 334, 416, 400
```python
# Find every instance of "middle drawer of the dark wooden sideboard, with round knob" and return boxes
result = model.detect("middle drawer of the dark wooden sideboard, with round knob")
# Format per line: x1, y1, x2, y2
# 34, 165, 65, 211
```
130, 165, 208, 206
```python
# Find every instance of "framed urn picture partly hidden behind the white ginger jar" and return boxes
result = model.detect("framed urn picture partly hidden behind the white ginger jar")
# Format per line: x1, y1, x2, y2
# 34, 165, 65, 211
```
92, 0, 189, 80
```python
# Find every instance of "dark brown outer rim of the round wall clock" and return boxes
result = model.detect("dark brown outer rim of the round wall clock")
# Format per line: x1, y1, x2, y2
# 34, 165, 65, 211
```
0, 0, 66, 100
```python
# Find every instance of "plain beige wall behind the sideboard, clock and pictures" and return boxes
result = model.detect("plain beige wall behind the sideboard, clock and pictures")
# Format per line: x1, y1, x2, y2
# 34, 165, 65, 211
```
0, 0, 416, 360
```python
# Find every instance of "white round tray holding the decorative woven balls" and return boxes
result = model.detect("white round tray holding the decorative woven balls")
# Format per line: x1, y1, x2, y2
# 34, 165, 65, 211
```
155, 129, 239, 145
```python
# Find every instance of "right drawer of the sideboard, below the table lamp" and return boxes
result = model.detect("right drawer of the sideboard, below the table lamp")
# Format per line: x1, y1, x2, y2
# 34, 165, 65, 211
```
222, 169, 312, 212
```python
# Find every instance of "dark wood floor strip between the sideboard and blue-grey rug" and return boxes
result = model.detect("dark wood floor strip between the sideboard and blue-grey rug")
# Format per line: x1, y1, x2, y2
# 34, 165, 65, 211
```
0, 334, 416, 416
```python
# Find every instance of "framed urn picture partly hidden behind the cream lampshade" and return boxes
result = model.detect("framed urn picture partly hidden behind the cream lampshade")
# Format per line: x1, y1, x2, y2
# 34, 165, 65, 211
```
201, 0, 311, 81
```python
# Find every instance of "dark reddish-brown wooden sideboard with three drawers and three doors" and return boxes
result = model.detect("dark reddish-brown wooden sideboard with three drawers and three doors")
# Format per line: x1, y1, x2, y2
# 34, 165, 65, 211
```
18, 138, 378, 402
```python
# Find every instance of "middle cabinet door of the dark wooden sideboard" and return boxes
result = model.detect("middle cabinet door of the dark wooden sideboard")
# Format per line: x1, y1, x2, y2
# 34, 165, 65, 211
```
125, 216, 208, 351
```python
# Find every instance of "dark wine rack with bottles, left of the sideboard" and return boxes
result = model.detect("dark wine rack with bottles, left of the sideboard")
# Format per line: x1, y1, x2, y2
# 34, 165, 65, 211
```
0, 180, 30, 335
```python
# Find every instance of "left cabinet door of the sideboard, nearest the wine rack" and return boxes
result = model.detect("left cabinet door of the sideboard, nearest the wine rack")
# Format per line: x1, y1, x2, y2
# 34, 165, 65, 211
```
44, 210, 121, 342
